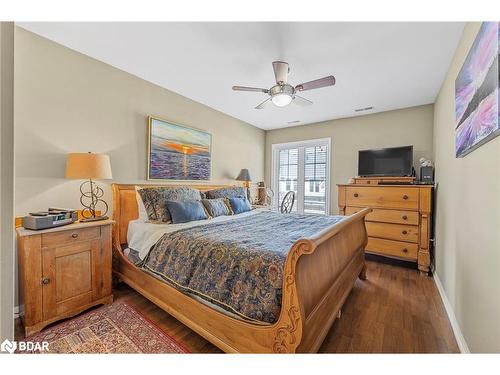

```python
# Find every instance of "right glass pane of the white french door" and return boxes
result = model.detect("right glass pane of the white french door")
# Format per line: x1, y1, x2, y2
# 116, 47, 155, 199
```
304, 146, 327, 214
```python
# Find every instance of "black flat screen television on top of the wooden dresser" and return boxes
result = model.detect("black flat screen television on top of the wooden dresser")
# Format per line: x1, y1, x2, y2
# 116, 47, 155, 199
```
358, 146, 413, 177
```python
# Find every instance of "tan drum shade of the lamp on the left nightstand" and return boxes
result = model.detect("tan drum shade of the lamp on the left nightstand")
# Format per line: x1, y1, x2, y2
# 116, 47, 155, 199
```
66, 152, 113, 180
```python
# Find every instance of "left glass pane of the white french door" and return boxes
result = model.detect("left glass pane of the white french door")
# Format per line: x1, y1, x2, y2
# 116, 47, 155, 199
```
278, 148, 299, 211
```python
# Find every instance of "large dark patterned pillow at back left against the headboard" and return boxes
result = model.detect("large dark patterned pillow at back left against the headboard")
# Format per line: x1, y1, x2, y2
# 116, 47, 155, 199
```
139, 186, 201, 223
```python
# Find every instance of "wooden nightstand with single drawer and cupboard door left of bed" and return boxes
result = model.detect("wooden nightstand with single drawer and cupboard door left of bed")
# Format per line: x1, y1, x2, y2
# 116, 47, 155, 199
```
17, 220, 114, 336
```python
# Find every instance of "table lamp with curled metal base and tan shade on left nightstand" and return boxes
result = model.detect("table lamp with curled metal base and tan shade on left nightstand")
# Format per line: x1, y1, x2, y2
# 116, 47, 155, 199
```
66, 152, 113, 222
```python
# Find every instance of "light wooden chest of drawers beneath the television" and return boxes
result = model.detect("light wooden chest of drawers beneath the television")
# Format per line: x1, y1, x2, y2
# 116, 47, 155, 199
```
337, 178, 433, 274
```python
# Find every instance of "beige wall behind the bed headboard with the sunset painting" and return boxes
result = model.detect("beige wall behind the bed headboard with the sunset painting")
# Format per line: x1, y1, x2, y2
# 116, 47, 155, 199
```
15, 28, 265, 215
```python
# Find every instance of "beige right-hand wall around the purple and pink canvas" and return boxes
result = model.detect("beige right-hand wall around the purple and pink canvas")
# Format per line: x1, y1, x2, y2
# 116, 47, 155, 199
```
434, 23, 500, 352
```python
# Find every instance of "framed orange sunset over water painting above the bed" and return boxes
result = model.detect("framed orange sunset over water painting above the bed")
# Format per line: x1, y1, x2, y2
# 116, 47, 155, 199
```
148, 116, 212, 181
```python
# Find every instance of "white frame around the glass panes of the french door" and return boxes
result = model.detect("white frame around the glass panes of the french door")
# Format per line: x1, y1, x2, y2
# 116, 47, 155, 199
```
271, 138, 332, 215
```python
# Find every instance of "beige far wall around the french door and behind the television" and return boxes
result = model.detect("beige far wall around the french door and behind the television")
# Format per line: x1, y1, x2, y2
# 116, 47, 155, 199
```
266, 105, 433, 213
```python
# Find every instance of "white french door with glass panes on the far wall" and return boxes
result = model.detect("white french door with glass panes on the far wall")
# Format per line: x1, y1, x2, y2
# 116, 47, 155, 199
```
272, 138, 330, 214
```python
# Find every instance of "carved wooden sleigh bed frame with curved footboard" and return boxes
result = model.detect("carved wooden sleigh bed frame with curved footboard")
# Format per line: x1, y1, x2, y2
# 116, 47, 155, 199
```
112, 184, 371, 353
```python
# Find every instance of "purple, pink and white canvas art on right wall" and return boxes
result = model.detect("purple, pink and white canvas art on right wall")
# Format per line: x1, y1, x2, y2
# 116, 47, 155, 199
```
455, 22, 500, 158
